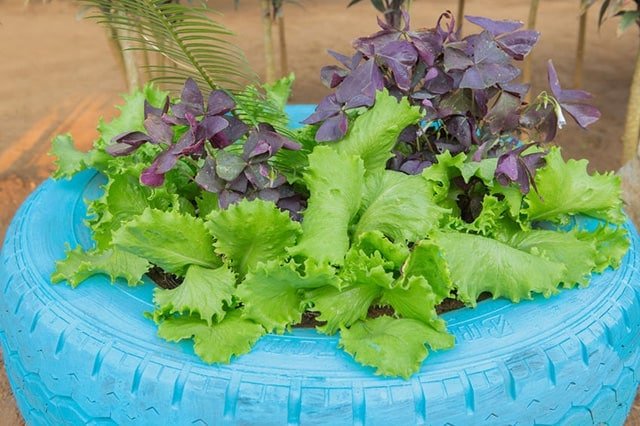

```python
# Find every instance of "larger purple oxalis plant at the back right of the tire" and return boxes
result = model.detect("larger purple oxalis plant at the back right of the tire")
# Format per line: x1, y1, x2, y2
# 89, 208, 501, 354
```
305, 12, 599, 193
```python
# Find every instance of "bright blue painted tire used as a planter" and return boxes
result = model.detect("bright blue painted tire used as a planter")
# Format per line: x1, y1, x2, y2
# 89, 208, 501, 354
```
0, 108, 640, 425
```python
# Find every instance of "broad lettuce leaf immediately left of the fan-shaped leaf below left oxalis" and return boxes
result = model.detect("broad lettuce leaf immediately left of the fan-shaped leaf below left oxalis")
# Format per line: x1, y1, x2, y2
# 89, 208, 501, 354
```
113, 208, 222, 275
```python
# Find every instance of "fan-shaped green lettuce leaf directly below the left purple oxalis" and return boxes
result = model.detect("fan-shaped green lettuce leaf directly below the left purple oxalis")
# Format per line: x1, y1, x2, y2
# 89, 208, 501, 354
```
206, 199, 300, 276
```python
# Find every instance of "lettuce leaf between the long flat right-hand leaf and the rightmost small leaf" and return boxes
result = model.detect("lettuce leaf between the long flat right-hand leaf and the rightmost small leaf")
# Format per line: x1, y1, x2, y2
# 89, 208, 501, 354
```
508, 230, 597, 287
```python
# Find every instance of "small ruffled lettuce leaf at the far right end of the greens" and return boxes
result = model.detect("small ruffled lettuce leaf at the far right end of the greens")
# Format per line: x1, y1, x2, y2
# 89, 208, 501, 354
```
575, 225, 630, 272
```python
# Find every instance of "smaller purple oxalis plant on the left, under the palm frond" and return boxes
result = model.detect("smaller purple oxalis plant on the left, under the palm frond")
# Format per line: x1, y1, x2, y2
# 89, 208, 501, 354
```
107, 79, 305, 218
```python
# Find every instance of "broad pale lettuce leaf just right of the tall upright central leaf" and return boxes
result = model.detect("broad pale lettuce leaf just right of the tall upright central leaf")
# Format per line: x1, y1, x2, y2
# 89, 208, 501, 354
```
354, 170, 446, 242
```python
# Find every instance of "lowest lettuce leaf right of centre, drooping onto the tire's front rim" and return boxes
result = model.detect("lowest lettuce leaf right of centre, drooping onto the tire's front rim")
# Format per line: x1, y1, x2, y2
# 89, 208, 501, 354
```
340, 316, 454, 379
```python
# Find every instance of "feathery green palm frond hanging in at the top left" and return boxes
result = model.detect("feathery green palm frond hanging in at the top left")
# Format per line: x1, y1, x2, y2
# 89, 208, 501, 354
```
80, 0, 257, 92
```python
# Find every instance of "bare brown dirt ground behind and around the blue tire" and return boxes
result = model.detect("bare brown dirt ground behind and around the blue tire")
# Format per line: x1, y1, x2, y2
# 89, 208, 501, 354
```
0, 0, 640, 425
